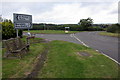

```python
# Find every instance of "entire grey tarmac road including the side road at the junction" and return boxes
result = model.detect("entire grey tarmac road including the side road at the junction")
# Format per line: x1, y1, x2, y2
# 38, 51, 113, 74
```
24, 31, 120, 62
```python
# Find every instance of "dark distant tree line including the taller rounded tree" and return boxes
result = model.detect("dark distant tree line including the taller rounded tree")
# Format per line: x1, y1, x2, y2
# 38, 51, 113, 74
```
31, 18, 103, 31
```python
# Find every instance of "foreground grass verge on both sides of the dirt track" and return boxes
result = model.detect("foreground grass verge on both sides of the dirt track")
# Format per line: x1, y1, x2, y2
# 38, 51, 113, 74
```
2, 38, 119, 78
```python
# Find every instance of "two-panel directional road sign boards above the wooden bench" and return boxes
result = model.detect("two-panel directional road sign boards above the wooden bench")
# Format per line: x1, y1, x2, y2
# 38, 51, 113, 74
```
13, 13, 32, 29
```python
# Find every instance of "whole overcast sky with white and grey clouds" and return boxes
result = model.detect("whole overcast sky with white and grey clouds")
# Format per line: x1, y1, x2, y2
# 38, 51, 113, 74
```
0, 0, 119, 24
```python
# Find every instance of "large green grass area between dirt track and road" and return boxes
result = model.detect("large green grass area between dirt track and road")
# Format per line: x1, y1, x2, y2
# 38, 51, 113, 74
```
37, 41, 118, 78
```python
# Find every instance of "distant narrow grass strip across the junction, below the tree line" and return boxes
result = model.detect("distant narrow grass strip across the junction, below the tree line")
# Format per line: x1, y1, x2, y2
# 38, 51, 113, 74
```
24, 30, 79, 34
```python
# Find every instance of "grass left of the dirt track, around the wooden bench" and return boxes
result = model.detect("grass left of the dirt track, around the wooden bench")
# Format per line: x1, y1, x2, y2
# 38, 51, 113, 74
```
2, 38, 45, 78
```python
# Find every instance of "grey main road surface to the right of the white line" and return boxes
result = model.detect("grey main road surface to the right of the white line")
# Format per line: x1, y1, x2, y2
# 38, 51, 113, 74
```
75, 31, 120, 63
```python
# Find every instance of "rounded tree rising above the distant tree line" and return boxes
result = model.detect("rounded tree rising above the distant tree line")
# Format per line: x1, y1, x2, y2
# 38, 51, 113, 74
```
78, 18, 93, 30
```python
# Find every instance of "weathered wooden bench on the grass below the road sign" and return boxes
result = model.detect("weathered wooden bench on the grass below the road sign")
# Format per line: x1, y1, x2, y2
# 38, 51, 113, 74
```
4, 37, 29, 58
